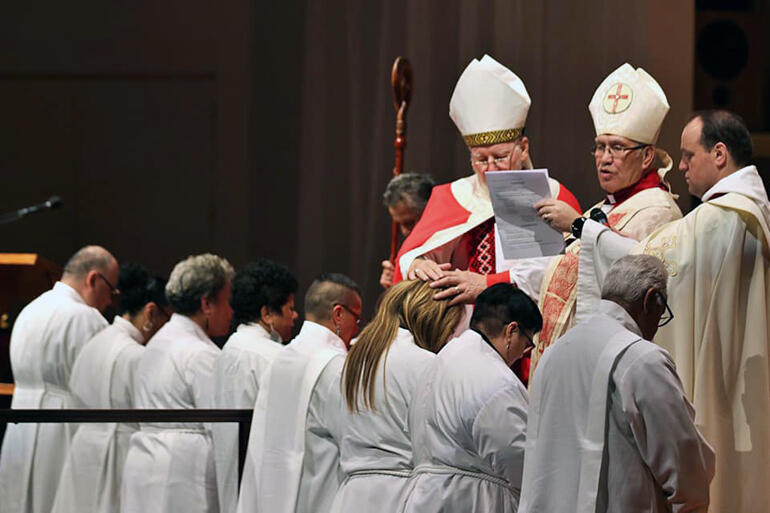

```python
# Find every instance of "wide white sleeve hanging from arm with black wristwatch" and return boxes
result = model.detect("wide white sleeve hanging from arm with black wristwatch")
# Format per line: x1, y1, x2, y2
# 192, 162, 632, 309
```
575, 219, 638, 323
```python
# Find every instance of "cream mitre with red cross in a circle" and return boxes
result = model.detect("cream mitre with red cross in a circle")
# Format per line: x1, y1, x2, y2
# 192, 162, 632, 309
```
588, 63, 669, 144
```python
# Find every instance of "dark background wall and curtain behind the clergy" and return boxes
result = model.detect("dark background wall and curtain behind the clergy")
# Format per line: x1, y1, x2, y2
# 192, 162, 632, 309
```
0, 0, 712, 320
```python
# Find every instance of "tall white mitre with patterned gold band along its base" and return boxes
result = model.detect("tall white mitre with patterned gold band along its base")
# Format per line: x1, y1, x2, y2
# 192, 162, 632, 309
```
449, 55, 532, 147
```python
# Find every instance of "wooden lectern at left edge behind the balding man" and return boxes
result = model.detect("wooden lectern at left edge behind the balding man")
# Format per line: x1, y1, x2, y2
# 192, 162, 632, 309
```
0, 253, 61, 440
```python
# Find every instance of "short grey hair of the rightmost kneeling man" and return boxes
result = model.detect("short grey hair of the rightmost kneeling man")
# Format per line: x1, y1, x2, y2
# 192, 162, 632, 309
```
602, 255, 668, 310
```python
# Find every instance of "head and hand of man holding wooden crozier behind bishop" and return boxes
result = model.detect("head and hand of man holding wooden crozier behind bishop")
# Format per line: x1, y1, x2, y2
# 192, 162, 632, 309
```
380, 173, 436, 289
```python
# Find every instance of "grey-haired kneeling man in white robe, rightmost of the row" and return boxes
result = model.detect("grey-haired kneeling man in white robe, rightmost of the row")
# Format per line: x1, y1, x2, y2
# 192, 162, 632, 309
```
519, 255, 714, 513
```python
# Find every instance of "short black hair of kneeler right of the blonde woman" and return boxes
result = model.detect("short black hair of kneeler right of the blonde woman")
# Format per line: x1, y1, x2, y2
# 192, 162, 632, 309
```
471, 283, 543, 337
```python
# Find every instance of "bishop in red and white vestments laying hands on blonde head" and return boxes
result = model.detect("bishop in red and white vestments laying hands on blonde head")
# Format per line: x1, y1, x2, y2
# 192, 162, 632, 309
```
393, 55, 580, 303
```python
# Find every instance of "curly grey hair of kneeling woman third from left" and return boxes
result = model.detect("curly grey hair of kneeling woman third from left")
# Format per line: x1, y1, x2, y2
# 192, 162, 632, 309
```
166, 253, 235, 315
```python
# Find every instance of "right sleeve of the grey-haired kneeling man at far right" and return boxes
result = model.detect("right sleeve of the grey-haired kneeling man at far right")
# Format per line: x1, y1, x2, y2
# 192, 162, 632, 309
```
614, 350, 714, 512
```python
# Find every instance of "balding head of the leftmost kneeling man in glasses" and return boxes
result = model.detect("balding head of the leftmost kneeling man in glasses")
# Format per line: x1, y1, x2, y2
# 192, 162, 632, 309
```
61, 246, 119, 312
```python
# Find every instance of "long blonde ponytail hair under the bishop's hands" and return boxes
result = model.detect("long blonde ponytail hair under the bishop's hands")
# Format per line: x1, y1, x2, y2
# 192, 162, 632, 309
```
342, 280, 465, 412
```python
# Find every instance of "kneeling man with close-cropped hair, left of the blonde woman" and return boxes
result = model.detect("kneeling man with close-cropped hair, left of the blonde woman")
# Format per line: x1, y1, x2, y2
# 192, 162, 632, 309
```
237, 273, 361, 513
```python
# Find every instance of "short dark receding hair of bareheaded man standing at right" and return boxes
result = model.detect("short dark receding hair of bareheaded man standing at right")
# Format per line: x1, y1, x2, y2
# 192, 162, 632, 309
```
688, 109, 754, 167
